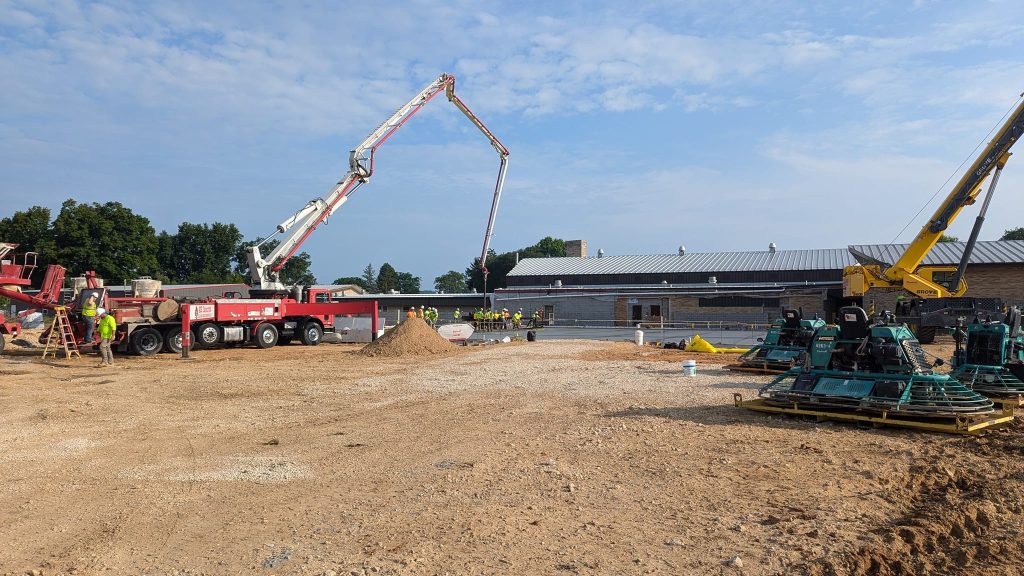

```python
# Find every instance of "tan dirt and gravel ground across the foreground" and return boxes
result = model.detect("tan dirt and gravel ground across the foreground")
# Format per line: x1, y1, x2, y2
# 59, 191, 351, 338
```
0, 334, 1024, 575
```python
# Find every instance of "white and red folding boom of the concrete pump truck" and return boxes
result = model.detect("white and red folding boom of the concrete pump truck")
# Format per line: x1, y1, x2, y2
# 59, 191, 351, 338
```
246, 74, 509, 291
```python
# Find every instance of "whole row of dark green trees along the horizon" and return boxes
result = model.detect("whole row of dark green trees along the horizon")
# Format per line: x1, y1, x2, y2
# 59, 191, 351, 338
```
0, 199, 569, 294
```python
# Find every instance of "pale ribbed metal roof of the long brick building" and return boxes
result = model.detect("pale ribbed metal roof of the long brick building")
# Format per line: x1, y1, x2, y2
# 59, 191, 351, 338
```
509, 240, 1024, 276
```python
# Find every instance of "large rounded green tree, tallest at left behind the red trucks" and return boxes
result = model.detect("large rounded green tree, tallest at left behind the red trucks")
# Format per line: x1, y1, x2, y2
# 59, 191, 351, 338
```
53, 200, 160, 282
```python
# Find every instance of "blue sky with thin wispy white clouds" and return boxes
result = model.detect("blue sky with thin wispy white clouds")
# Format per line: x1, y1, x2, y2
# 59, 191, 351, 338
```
0, 0, 1024, 288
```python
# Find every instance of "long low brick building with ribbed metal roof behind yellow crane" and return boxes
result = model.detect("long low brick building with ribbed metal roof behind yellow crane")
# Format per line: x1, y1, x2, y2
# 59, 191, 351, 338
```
495, 241, 1024, 325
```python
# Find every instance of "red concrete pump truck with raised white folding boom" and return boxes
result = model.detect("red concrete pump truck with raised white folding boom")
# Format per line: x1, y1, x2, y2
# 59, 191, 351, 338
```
0, 74, 509, 356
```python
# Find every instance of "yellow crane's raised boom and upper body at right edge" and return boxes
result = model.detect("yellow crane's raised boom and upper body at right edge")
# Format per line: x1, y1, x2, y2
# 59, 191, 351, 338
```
843, 93, 1024, 298
